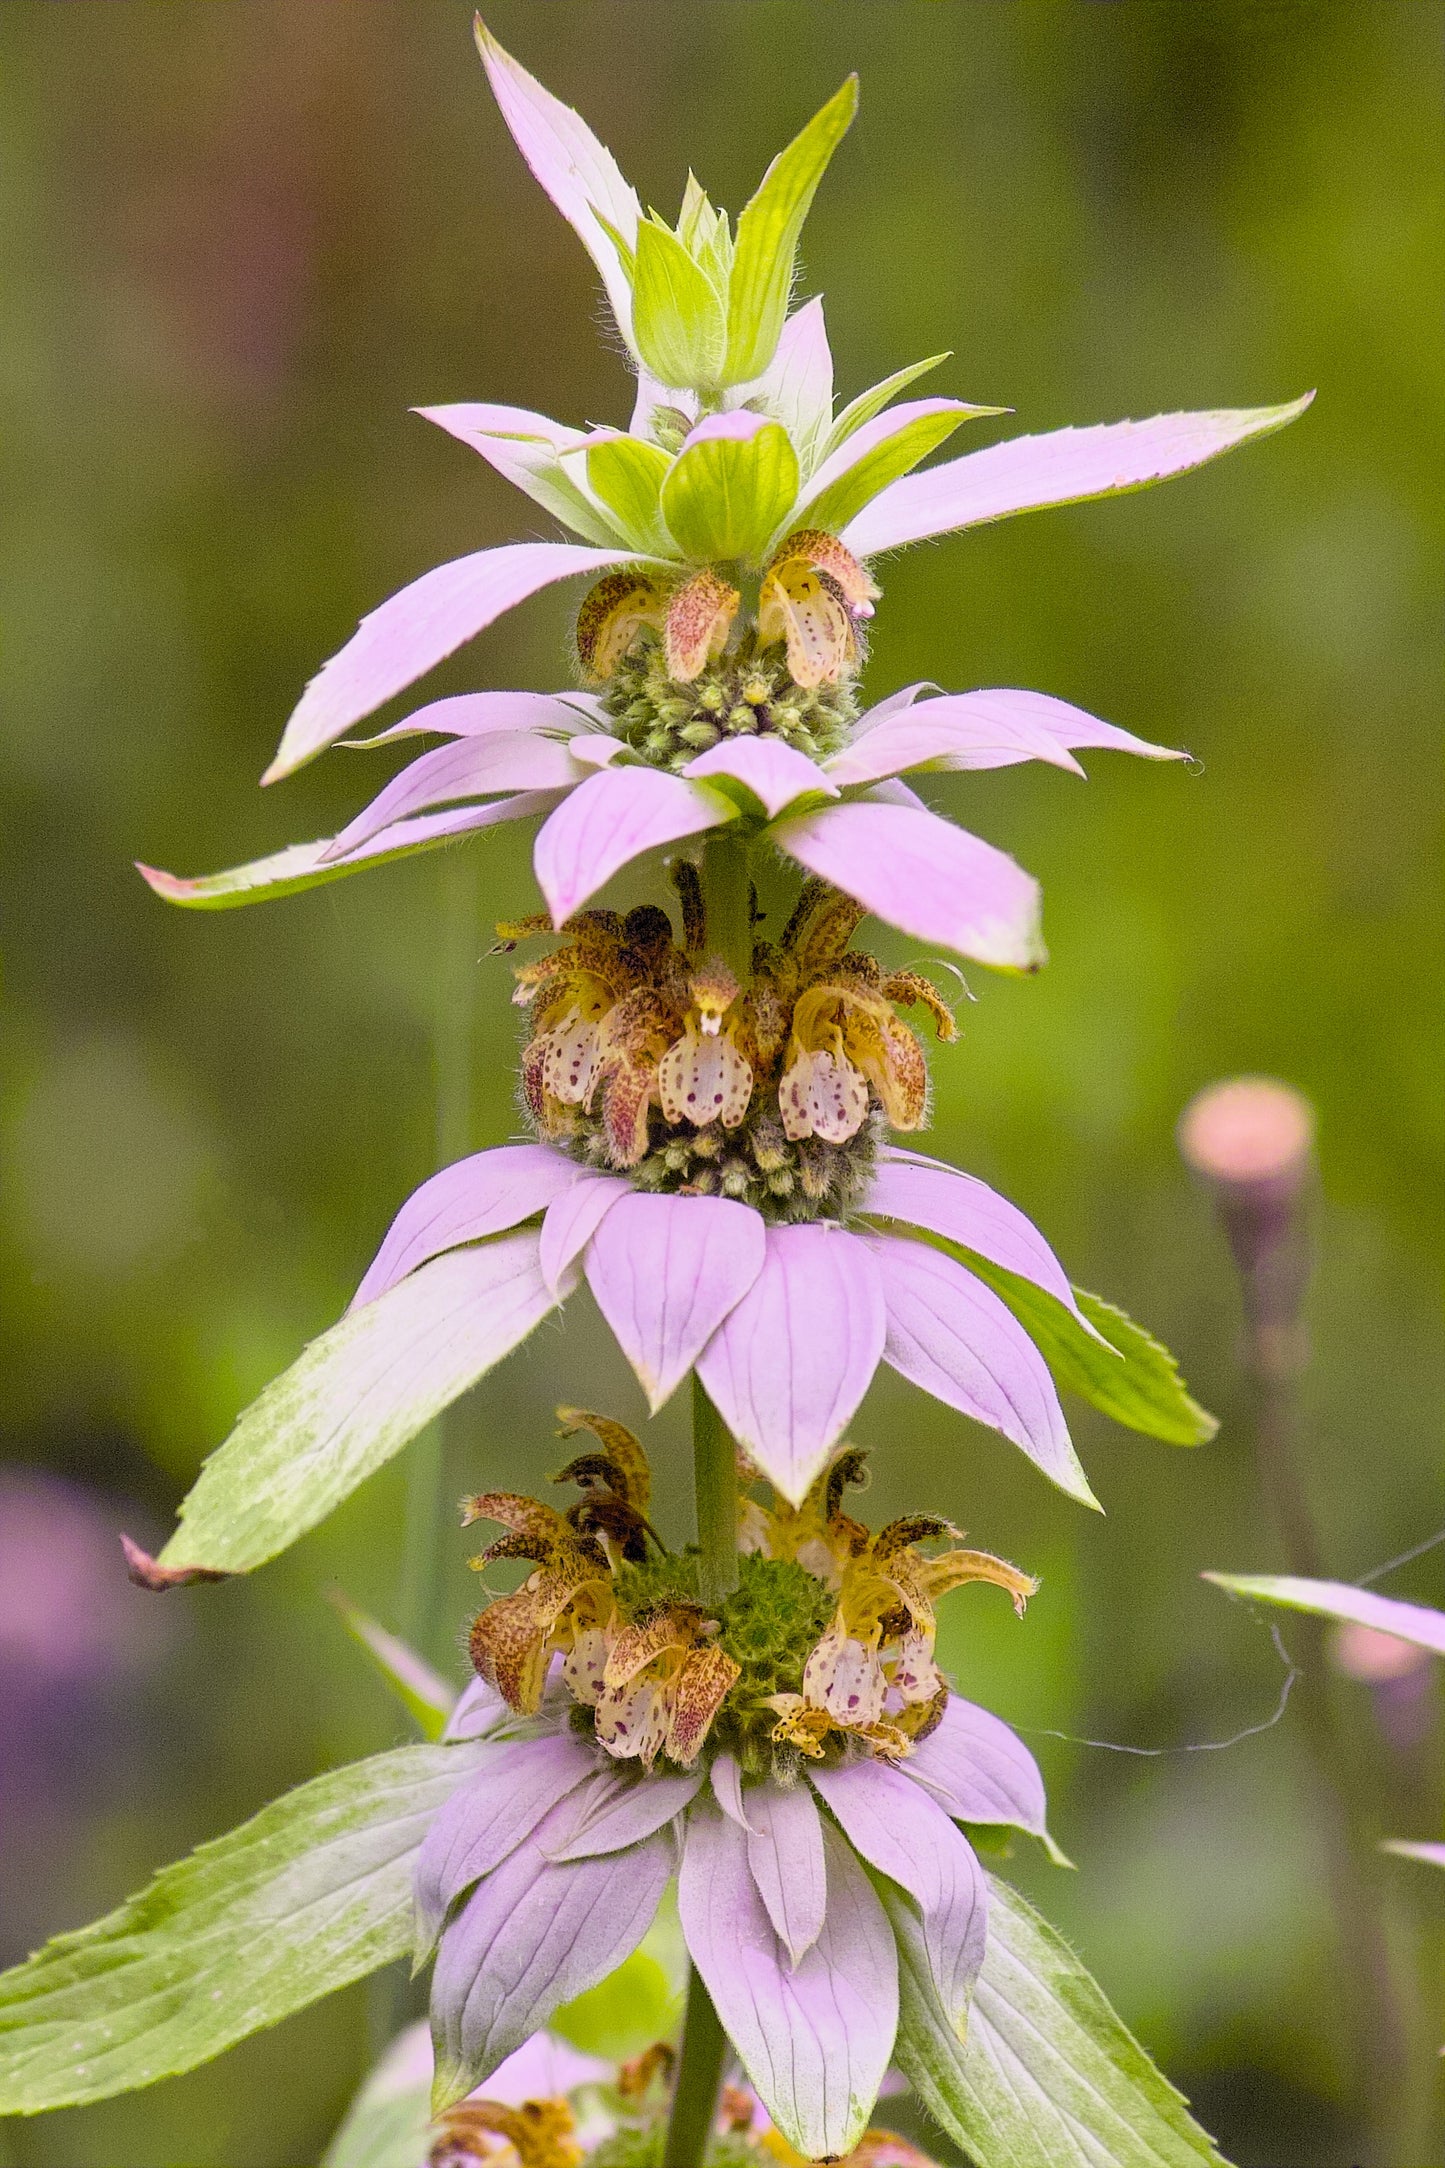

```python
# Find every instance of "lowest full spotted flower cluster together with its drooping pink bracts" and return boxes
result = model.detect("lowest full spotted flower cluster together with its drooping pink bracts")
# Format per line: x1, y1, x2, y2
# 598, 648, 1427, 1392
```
416, 1409, 1049, 2157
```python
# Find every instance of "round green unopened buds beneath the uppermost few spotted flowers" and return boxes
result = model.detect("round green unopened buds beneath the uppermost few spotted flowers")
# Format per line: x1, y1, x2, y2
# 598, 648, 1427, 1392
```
604, 635, 858, 770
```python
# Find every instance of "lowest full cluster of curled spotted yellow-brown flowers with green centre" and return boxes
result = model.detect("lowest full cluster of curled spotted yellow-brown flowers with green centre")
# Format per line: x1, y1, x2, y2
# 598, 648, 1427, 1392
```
466, 1407, 1036, 1782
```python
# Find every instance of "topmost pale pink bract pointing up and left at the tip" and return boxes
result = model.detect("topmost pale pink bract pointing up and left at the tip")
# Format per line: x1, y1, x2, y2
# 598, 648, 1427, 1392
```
477, 22, 641, 343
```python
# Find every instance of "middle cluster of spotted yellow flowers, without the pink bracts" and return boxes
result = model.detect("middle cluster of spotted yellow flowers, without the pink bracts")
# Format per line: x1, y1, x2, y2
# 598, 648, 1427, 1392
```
498, 861, 955, 1218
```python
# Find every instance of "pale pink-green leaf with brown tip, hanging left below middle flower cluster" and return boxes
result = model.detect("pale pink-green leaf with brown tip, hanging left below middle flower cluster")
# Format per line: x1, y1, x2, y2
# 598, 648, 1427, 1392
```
158, 1234, 555, 1574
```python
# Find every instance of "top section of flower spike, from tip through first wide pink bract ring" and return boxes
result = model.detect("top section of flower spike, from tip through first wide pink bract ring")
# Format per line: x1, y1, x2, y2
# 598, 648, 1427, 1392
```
143, 14, 1306, 971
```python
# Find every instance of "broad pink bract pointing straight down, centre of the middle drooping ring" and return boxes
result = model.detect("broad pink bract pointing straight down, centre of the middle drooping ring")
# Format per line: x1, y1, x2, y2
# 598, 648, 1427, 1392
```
698, 1223, 886, 1505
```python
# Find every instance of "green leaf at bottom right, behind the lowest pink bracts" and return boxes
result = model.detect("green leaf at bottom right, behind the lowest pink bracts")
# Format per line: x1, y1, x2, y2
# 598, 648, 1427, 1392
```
880, 1875, 1222, 2168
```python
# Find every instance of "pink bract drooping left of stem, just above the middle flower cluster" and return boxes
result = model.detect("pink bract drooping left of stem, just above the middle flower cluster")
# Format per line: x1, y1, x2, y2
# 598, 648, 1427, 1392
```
533, 767, 737, 926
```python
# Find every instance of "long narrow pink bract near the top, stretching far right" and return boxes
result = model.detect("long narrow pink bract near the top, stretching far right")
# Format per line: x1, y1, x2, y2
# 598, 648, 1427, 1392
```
843, 392, 1315, 557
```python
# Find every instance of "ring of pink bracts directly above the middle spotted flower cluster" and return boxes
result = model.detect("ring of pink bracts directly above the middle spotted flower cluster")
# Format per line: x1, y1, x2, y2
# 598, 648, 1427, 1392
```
143, 685, 1181, 971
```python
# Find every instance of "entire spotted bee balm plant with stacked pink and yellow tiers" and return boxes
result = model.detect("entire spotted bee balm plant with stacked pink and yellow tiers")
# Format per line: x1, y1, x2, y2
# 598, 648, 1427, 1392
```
0, 26, 1304, 2168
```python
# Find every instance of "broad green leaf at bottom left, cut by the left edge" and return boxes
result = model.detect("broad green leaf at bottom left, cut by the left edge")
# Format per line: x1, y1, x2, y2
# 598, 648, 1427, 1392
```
0, 1741, 490, 2116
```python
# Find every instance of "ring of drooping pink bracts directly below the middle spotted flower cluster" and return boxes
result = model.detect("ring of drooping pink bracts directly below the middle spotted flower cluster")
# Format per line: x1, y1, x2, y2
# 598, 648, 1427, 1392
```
351, 1145, 1096, 1505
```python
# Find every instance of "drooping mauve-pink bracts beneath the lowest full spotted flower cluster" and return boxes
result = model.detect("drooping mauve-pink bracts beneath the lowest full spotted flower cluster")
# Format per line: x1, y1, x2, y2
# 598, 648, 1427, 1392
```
416, 1680, 1049, 2157
